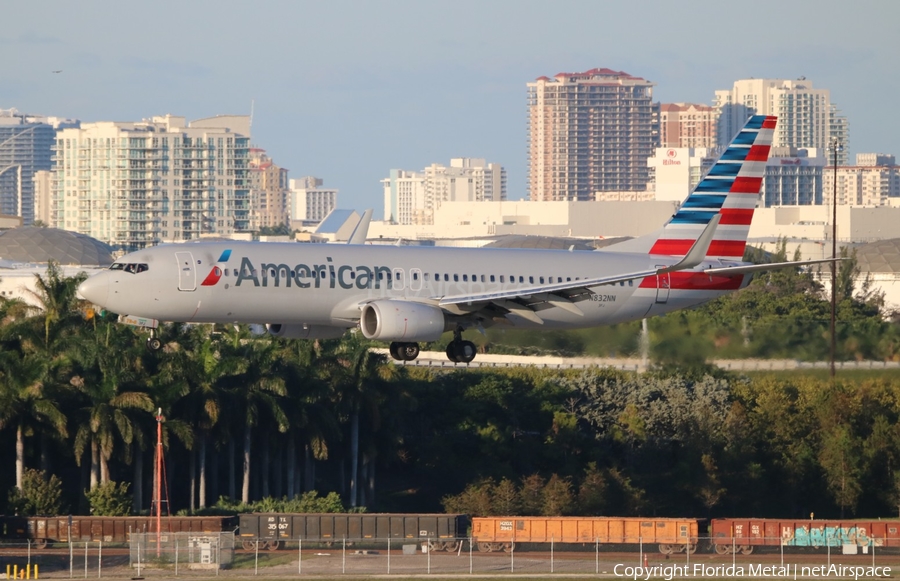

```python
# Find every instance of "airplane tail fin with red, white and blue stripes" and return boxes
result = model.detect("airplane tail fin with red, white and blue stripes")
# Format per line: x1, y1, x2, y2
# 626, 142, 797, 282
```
623, 115, 777, 260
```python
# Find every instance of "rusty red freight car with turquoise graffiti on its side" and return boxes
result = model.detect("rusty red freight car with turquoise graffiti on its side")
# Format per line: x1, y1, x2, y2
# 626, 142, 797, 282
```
709, 518, 900, 555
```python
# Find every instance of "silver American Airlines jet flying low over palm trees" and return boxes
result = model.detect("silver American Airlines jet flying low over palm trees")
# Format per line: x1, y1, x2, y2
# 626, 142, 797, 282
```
78, 115, 834, 363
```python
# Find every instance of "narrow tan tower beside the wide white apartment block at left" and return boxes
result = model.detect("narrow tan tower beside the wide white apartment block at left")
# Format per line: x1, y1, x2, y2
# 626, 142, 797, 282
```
247, 147, 291, 228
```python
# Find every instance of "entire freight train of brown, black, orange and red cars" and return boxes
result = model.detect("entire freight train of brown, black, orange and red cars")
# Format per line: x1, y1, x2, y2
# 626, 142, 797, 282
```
0, 513, 900, 555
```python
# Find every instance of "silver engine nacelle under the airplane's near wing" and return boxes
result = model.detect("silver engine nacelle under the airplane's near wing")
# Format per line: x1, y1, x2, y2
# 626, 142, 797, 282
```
359, 300, 446, 342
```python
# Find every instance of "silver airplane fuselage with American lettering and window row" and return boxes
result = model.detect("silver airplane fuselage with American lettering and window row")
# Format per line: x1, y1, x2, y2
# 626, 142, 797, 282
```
81, 242, 749, 328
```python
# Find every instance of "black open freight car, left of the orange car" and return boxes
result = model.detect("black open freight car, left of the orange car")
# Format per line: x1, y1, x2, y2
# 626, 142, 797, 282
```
240, 513, 468, 551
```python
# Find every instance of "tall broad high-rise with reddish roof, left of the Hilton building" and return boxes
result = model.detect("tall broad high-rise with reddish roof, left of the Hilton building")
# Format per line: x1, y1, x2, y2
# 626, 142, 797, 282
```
527, 69, 659, 201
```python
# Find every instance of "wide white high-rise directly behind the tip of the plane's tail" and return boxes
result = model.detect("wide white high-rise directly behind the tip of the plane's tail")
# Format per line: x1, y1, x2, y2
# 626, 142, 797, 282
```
714, 77, 850, 165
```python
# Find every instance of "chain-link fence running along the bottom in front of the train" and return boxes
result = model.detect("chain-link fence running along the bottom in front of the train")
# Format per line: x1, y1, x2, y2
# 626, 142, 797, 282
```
0, 533, 900, 579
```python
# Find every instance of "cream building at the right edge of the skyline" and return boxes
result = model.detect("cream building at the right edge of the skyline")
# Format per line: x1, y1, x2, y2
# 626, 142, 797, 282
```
822, 153, 900, 206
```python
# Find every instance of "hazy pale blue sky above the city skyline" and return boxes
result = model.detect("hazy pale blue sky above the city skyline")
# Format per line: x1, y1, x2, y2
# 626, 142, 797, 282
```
0, 0, 900, 216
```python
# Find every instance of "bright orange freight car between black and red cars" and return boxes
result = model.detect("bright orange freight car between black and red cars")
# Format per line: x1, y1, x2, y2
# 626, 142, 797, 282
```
472, 516, 699, 555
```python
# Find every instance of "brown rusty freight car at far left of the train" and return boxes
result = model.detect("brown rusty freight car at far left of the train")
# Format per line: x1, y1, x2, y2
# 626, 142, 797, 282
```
0, 515, 234, 548
